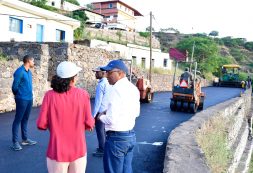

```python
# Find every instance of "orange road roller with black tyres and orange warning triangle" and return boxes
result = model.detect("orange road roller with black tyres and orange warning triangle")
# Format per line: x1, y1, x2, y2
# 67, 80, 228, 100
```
170, 62, 205, 113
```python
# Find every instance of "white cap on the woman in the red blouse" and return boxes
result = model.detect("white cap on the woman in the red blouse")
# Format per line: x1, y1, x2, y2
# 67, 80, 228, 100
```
56, 61, 82, 78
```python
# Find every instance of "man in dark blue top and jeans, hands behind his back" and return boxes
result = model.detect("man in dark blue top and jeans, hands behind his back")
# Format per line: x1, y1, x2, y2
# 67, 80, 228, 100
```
11, 55, 37, 151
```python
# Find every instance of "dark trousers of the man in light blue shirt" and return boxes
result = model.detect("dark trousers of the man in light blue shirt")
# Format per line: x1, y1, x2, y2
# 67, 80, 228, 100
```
95, 118, 105, 151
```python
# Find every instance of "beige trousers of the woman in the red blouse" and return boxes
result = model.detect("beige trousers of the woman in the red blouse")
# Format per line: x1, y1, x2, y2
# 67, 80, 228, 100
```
47, 155, 87, 173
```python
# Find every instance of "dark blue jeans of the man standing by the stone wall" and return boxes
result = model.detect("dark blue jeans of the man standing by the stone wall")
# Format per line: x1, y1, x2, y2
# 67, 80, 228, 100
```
12, 99, 33, 143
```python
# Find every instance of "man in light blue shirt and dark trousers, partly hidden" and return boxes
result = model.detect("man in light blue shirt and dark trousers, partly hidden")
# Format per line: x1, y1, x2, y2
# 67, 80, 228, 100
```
92, 67, 110, 157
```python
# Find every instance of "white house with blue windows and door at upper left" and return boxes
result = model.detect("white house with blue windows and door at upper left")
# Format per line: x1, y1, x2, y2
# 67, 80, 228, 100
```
0, 0, 80, 43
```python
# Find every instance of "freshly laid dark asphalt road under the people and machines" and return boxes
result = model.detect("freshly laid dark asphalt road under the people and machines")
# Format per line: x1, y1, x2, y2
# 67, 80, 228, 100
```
0, 87, 241, 173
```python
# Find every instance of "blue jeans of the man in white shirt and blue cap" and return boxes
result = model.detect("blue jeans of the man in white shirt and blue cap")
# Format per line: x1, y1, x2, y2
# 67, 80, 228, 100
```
103, 130, 136, 173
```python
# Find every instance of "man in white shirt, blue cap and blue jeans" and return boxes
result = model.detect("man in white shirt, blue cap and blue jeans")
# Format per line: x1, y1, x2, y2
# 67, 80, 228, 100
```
97, 60, 140, 173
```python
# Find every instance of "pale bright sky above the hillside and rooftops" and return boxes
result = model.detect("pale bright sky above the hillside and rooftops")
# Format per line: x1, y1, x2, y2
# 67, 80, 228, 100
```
78, 0, 253, 41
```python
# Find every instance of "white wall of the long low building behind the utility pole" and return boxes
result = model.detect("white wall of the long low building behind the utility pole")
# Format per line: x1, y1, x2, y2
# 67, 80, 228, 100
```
90, 40, 172, 69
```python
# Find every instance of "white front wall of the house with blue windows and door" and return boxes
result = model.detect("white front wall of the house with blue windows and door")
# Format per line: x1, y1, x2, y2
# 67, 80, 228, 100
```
0, 5, 73, 42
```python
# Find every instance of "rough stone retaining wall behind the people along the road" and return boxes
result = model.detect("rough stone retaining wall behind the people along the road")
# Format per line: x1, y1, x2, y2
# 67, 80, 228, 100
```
0, 42, 212, 112
